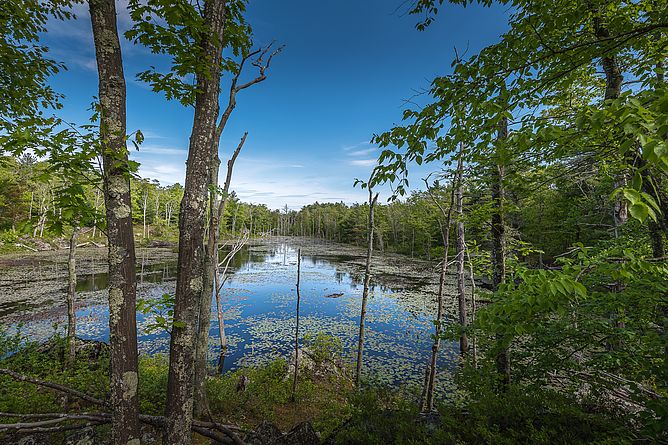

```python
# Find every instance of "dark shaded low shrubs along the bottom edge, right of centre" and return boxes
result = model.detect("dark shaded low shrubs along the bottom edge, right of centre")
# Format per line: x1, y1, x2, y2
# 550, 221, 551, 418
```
336, 387, 633, 445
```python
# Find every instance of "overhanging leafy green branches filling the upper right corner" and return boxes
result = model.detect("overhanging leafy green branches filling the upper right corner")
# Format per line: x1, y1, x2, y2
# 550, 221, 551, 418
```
374, 0, 668, 219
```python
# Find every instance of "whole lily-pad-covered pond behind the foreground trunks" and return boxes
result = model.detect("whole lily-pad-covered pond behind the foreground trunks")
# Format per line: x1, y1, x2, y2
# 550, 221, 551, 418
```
0, 238, 456, 386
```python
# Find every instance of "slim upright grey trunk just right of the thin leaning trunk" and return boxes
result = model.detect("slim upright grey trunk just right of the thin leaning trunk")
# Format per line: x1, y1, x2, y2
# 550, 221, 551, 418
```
455, 151, 469, 356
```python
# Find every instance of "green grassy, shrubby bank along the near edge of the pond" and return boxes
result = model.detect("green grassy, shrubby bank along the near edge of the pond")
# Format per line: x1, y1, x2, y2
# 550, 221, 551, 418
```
0, 336, 635, 444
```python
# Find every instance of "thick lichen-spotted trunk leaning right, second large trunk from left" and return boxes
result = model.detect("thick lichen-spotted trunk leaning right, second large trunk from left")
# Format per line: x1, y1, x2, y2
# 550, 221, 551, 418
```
164, 0, 226, 445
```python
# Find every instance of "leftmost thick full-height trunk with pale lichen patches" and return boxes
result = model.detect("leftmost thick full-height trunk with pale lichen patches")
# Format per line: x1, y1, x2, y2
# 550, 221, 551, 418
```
88, 0, 140, 445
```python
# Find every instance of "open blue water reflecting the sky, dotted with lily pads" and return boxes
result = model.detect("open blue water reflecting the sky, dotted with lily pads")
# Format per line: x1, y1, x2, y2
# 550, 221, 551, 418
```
11, 243, 455, 384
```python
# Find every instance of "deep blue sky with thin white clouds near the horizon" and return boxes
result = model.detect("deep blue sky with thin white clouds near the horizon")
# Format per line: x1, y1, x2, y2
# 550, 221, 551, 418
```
44, 0, 508, 209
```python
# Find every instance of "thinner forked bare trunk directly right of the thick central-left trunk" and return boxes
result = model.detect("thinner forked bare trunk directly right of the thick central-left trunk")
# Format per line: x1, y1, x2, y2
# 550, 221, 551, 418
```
195, 132, 248, 416
